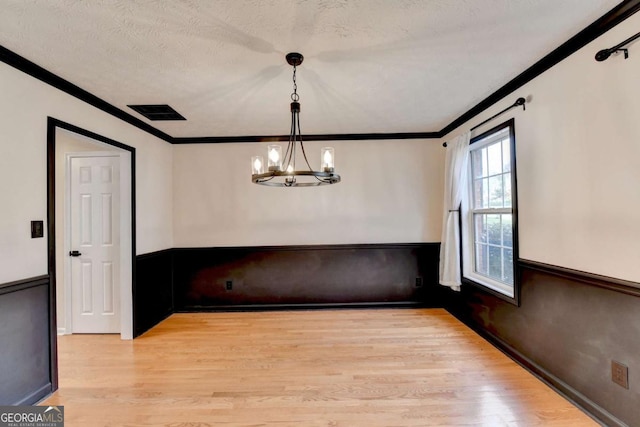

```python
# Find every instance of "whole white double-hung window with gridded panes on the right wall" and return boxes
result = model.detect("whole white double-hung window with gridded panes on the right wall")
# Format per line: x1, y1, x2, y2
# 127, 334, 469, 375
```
462, 120, 518, 303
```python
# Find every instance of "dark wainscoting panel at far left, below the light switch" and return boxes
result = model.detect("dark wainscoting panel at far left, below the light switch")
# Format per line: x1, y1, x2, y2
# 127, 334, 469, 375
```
0, 276, 53, 405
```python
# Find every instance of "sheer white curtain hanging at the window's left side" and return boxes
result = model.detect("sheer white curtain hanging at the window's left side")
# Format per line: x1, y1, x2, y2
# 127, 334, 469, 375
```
440, 132, 471, 291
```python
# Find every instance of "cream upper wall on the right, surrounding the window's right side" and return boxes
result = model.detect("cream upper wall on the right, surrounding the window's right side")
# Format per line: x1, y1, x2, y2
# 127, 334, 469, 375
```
445, 14, 640, 282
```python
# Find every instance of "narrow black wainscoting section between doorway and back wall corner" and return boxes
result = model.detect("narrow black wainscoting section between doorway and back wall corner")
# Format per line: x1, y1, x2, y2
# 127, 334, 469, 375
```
133, 249, 173, 337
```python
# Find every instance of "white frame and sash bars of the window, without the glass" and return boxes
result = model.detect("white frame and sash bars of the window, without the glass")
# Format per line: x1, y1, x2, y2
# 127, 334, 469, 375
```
461, 119, 520, 304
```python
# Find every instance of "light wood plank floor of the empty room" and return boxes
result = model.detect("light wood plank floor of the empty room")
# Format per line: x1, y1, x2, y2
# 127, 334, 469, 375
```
41, 309, 597, 427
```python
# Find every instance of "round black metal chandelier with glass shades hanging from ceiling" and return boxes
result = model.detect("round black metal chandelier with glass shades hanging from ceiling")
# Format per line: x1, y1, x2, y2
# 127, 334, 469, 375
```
251, 52, 340, 187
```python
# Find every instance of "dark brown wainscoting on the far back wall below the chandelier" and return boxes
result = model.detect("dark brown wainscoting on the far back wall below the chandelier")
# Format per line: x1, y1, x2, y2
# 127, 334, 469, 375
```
174, 243, 440, 311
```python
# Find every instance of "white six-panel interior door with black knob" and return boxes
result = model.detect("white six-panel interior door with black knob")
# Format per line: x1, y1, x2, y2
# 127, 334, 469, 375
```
69, 156, 120, 333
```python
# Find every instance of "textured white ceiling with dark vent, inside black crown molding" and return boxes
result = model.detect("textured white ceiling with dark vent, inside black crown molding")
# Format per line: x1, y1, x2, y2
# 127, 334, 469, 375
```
0, 0, 619, 137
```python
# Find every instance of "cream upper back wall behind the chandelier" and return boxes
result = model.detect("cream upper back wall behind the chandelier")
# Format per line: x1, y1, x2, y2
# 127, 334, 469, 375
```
173, 140, 445, 247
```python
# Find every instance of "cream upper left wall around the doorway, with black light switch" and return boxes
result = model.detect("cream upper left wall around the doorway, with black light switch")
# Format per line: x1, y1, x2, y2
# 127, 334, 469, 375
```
0, 63, 173, 283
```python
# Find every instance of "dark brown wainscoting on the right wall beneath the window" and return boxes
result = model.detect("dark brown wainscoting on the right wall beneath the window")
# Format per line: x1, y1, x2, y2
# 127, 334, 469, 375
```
445, 260, 640, 426
